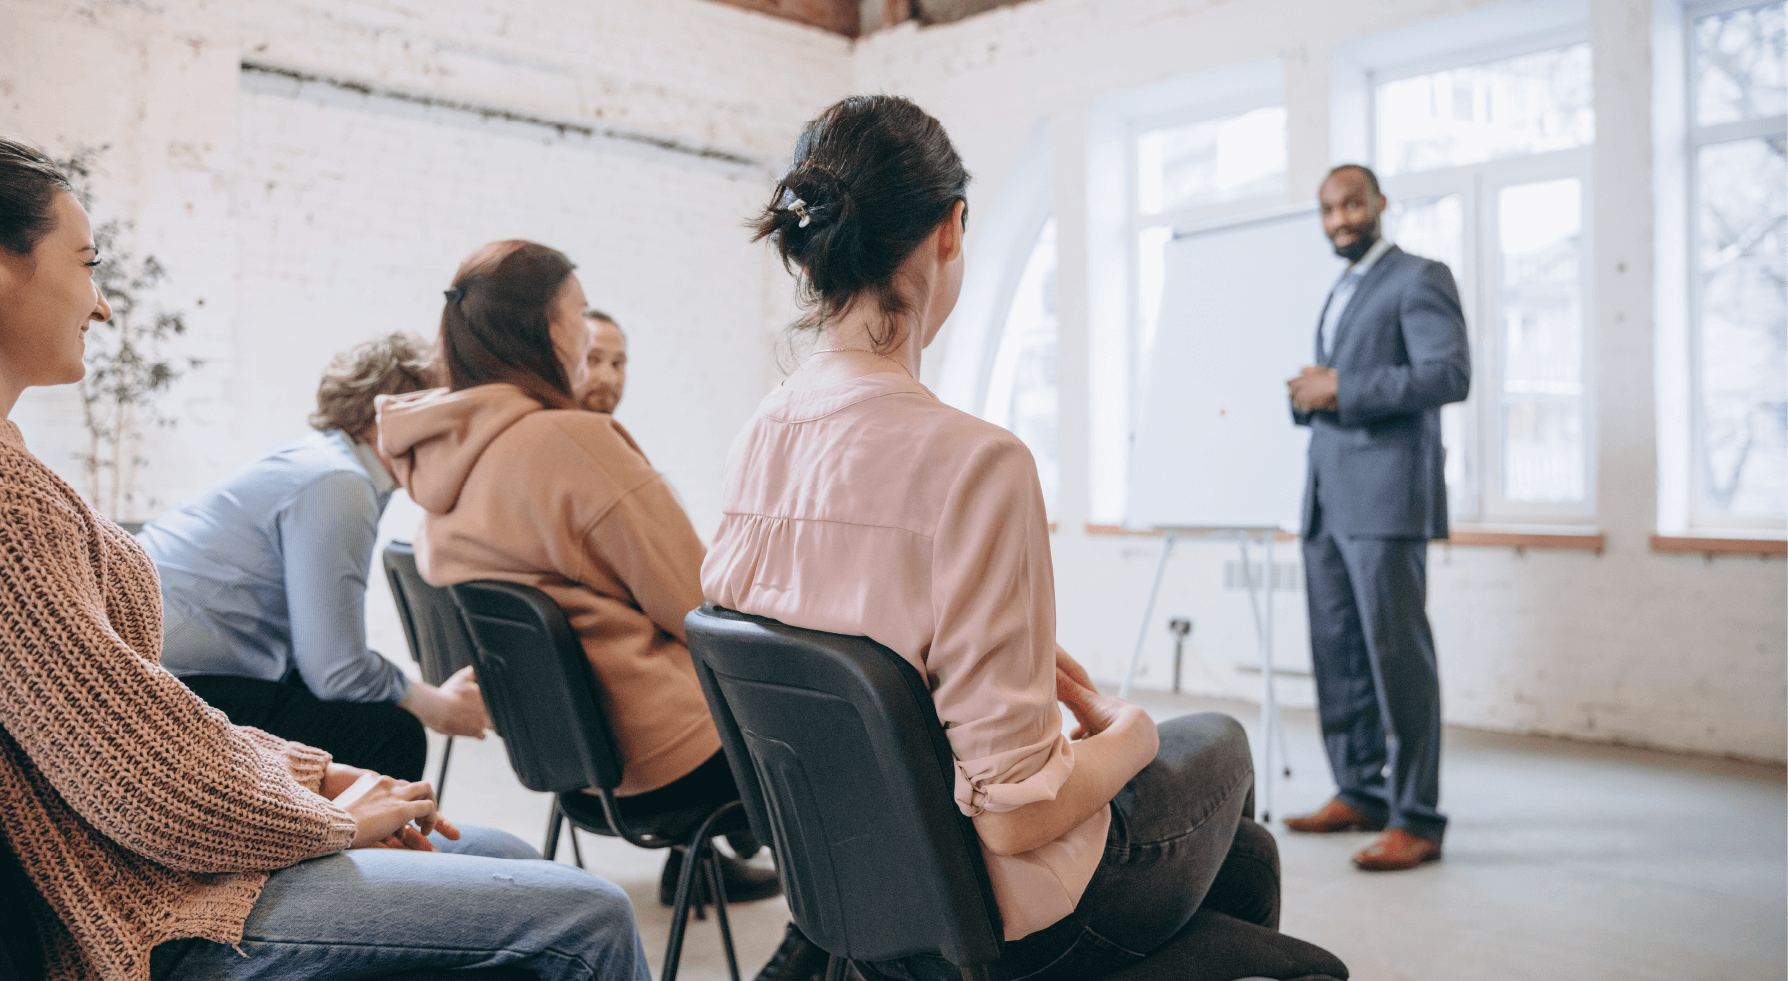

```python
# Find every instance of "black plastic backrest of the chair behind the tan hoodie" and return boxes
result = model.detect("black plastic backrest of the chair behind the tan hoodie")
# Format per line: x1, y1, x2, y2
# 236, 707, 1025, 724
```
447, 579, 622, 793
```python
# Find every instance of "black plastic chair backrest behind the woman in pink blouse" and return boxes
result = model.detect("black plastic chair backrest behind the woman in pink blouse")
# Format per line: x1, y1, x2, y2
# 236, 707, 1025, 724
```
685, 606, 1001, 968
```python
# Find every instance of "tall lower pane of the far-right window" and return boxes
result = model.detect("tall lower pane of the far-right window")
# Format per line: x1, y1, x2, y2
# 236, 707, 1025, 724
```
1695, 136, 1788, 518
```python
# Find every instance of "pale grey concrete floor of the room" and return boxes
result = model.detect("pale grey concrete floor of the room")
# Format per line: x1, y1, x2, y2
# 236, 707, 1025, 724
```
429, 693, 1788, 981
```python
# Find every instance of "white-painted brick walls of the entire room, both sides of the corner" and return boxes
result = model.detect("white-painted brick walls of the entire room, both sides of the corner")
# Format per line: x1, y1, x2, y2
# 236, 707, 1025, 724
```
0, 0, 1788, 758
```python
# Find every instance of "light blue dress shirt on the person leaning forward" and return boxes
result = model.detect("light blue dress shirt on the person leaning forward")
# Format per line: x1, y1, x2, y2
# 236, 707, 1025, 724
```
138, 431, 409, 702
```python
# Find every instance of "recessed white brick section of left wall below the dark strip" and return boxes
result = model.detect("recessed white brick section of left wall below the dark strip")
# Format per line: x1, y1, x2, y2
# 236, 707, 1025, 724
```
232, 75, 769, 527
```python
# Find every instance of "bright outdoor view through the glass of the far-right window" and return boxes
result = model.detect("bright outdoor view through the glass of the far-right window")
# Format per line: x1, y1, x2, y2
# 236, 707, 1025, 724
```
1686, 2, 1788, 529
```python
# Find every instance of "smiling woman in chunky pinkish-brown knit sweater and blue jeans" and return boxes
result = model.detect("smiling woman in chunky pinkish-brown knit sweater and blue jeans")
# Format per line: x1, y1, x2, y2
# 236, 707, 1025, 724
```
0, 139, 649, 981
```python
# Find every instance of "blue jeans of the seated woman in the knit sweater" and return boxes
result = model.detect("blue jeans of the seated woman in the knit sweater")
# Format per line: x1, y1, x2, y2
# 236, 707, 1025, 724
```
150, 827, 651, 981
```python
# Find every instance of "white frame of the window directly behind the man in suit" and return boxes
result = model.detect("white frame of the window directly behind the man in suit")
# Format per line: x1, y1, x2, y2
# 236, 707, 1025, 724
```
1364, 25, 1600, 527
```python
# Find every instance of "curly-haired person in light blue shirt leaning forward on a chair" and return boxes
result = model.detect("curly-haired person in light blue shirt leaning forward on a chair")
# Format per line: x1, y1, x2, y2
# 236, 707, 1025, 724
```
138, 334, 490, 781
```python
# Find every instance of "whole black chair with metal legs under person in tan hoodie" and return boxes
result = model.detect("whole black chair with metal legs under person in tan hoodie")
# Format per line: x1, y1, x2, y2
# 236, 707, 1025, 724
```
449, 581, 747, 981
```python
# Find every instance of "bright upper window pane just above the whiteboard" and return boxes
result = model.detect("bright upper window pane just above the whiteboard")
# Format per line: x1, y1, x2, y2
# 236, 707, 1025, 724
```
1137, 105, 1286, 214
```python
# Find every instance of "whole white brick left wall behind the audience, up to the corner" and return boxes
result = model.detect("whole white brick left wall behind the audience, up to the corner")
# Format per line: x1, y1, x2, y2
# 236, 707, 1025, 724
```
0, 0, 849, 531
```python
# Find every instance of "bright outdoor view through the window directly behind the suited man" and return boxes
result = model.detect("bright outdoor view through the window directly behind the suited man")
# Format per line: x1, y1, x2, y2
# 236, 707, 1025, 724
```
1371, 39, 1595, 524
